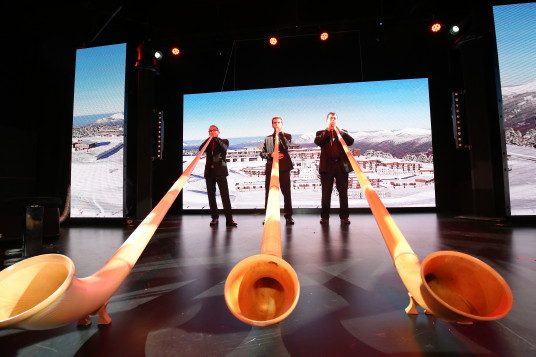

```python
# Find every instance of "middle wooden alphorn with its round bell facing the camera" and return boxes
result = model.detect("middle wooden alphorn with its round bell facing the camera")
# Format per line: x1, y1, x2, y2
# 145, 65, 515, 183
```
224, 132, 300, 326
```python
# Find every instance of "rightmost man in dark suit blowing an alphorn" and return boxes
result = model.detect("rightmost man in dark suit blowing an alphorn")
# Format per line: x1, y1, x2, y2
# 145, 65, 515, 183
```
315, 112, 354, 224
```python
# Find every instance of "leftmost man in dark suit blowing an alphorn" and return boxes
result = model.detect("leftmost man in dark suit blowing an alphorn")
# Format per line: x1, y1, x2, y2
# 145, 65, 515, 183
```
199, 125, 238, 227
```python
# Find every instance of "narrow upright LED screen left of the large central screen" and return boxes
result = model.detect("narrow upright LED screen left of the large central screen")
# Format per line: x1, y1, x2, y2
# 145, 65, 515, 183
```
71, 44, 126, 218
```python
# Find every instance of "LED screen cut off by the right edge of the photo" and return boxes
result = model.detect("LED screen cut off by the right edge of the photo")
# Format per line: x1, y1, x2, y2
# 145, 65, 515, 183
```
493, 2, 536, 215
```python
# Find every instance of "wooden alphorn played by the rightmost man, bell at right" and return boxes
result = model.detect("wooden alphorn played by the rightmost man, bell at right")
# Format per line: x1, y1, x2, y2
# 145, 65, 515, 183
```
335, 127, 513, 323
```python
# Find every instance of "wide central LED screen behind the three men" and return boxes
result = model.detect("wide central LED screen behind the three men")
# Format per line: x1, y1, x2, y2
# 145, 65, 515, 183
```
183, 78, 435, 210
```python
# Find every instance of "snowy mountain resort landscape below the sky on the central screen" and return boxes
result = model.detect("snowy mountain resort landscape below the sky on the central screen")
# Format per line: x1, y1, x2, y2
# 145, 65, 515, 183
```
183, 128, 436, 209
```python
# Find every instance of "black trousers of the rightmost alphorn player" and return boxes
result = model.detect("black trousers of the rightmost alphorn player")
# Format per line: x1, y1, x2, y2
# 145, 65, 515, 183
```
320, 162, 350, 219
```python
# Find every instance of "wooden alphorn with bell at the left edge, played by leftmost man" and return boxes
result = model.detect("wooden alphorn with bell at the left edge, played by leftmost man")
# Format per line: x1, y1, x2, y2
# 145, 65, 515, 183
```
0, 138, 212, 330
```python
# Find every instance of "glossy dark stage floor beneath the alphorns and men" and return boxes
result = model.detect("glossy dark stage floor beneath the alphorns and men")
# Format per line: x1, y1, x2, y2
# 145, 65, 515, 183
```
0, 213, 536, 357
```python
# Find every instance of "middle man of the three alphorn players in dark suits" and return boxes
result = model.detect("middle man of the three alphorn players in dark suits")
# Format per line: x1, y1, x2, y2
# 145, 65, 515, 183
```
261, 117, 294, 224
